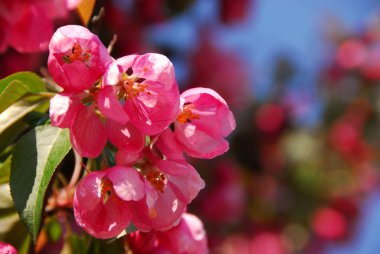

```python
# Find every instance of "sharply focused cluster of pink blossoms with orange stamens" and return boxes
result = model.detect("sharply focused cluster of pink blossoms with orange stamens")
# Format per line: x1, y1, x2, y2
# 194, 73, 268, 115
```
48, 25, 235, 242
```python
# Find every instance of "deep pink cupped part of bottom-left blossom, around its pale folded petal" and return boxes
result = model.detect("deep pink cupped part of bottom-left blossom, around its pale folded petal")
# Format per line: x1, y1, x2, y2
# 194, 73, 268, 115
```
73, 171, 131, 239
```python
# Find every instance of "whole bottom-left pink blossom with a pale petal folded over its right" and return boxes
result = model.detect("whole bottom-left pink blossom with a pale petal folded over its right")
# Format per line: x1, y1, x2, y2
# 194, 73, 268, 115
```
73, 166, 144, 238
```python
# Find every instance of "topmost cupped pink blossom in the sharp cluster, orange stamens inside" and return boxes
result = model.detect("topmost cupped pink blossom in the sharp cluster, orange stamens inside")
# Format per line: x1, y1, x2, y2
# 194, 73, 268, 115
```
48, 25, 112, 92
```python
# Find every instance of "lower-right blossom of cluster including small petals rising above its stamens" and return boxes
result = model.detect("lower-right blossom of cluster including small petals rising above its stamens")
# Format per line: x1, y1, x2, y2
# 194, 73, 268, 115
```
116, 130, 204, 231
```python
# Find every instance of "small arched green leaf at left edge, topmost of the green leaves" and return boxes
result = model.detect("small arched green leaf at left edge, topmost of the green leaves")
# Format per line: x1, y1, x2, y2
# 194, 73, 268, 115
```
0, 71, 46, 94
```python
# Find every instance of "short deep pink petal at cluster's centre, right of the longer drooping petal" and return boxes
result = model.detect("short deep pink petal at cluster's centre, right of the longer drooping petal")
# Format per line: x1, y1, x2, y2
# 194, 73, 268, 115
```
106, 120, 145, 153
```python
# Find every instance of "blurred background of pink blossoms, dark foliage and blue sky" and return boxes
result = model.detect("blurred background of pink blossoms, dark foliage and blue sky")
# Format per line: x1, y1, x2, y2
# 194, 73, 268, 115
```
0, 0, 380, 254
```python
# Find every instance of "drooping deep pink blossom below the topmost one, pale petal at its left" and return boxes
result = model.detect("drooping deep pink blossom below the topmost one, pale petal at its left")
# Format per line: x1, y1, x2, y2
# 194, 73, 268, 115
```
49, 92, 145, 158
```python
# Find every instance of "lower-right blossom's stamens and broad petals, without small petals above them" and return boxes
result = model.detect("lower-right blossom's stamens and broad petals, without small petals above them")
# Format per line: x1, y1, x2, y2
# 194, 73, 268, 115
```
127, 160, 204, 231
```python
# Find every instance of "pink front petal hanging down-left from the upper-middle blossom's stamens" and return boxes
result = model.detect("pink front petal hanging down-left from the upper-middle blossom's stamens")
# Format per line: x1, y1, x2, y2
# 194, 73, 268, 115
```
97, 86, 129, 124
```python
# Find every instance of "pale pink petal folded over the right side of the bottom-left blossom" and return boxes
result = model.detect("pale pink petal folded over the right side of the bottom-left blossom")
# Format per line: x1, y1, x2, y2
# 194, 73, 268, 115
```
107, 166, 145, 201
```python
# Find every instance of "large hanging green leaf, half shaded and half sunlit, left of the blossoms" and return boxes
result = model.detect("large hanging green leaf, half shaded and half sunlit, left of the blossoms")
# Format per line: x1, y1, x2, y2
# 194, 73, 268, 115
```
10, 125, 71, 242
